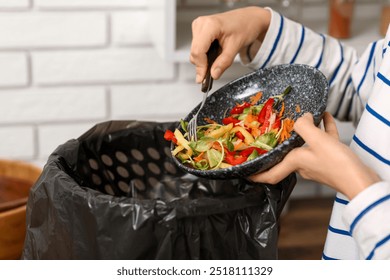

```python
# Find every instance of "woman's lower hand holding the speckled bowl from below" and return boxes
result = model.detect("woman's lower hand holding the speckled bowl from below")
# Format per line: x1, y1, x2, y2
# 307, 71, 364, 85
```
250, 112, 380, 199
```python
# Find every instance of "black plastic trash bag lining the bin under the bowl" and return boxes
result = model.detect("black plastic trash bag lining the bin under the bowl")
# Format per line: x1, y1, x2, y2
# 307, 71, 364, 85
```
22, 121, 296, 259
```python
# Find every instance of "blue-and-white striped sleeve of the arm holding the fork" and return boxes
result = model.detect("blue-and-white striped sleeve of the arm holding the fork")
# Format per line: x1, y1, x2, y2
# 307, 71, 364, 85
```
245, 9, 380, 124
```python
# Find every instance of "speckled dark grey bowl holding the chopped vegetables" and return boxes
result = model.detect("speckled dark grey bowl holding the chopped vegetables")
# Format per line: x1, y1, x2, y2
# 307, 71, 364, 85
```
172, 64, 328, 179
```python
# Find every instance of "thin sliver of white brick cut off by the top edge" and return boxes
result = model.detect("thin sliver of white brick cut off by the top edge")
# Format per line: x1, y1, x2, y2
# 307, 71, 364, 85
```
34, 0, 149, 9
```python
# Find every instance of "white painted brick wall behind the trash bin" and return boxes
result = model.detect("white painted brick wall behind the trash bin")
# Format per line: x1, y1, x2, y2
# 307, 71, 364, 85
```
0, 0, 190, 165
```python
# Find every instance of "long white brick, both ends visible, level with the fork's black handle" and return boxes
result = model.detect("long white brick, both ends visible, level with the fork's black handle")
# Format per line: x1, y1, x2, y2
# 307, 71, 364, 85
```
32, 48, 174, 85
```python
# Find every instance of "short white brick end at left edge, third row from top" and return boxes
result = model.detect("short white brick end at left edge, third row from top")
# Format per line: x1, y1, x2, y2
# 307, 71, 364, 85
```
0, 53, 28, 87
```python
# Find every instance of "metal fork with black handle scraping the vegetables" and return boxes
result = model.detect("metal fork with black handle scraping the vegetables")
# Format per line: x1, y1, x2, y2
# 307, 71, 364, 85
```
187, 40, 219, 141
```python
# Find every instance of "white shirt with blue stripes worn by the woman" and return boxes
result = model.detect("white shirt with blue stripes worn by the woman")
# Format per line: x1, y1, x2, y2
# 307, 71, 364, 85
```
246, 9, 390, 259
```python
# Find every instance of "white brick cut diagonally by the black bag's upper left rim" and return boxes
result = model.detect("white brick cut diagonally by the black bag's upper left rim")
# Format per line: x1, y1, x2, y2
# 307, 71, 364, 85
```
38, 122, 95, 158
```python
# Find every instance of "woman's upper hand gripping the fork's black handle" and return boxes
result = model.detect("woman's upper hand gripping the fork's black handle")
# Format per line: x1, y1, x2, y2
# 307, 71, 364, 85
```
190, 7, 271, 83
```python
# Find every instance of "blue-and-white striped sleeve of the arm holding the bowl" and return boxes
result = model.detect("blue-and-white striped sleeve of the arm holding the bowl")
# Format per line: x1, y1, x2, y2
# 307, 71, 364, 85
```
343, 182, 390, 259
